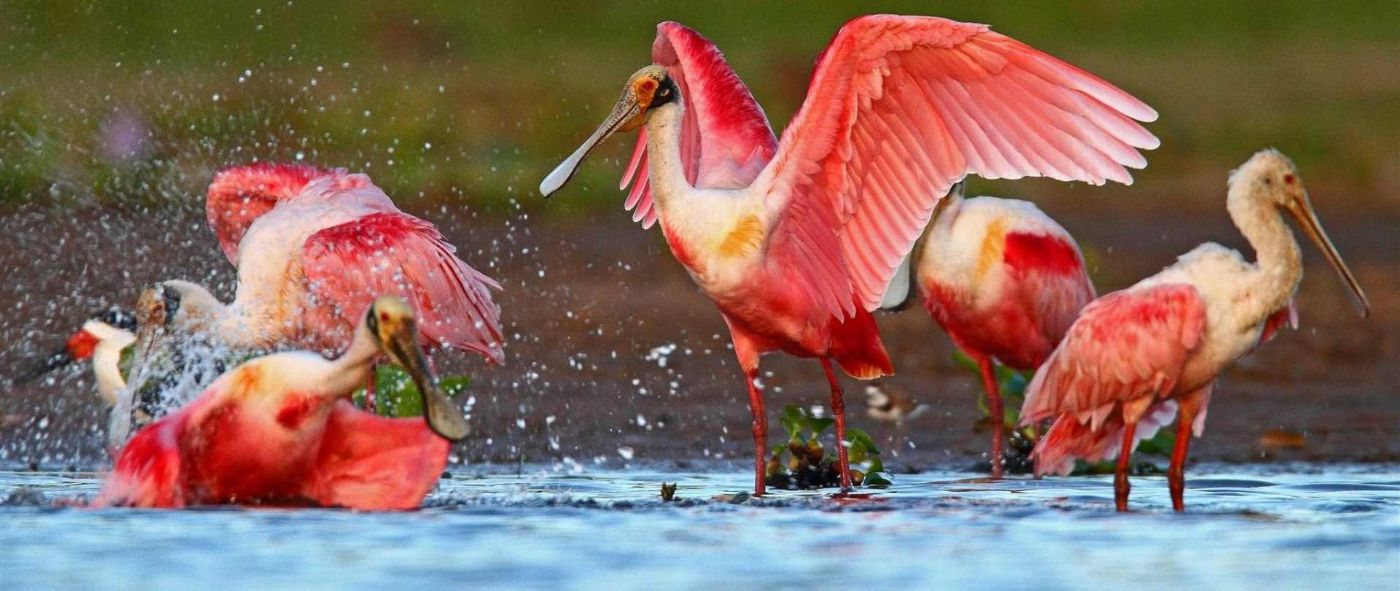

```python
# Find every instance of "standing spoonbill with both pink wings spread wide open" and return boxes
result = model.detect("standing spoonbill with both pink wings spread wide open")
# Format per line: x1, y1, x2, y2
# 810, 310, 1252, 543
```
540, 15, 1158, 494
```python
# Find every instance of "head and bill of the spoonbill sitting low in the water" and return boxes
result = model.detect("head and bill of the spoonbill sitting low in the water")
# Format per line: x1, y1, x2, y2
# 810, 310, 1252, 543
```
364, 296, 472, 441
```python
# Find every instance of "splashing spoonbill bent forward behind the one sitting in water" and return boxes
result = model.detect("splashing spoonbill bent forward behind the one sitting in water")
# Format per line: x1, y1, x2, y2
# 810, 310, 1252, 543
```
109, 164, 503, 444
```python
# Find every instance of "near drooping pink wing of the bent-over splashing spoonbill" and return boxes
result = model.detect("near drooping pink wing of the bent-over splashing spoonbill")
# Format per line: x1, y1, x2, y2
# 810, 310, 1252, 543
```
301, 211, 504, 363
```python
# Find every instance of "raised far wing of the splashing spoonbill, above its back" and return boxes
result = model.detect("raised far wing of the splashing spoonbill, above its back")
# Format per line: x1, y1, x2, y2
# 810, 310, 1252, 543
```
204, 162, 368, 266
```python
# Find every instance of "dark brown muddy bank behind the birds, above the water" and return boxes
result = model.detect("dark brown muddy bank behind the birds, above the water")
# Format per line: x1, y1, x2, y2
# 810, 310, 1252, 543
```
0, 202, 1400, 471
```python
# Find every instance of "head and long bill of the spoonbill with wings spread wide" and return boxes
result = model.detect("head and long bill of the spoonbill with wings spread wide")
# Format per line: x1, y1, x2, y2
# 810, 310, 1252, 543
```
539, 64, 680, 197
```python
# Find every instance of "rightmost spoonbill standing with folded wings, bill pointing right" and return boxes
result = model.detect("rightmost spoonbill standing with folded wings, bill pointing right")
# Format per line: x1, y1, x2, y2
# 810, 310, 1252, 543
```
1021, 150, 1371, 511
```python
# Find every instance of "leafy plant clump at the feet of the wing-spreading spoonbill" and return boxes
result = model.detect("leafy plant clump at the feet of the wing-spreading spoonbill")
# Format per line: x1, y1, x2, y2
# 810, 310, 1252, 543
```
764, 405, 890, 490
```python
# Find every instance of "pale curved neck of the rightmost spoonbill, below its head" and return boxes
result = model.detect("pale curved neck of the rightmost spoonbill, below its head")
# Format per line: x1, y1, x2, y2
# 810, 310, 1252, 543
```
1226, 185, 1303, 324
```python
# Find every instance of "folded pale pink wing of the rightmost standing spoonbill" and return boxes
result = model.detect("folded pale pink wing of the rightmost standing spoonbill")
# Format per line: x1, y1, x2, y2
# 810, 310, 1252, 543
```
1021, 283, 1205, 430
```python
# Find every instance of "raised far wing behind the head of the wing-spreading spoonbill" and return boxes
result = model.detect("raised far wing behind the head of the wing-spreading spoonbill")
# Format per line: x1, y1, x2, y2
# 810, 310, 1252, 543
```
620, 22, 777, 227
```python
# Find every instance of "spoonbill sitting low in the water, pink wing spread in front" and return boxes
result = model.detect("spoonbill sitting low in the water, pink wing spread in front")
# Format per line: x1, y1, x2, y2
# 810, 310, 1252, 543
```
97, 296, 469, 510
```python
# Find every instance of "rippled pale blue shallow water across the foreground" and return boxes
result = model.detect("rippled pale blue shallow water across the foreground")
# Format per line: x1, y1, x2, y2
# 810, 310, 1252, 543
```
0, 465, 1400, 591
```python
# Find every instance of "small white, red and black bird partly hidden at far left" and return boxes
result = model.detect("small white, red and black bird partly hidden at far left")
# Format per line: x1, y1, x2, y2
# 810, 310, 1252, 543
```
15, 308, 136, 406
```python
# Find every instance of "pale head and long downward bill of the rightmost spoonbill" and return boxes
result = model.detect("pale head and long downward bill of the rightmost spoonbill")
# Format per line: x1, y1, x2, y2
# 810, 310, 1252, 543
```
1229, 148, 1371, 317
